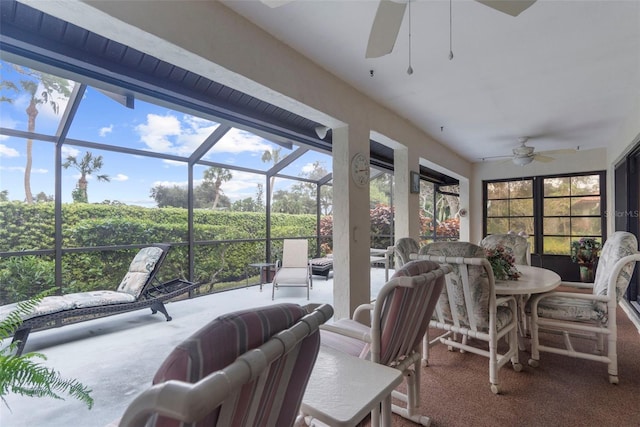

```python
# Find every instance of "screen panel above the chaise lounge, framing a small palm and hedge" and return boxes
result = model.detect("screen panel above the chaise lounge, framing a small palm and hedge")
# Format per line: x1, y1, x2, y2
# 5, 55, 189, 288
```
61, 147, 188, 247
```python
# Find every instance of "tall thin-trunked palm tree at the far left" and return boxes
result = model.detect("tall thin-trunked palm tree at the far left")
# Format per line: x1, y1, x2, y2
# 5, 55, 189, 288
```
0, 64, 71, 203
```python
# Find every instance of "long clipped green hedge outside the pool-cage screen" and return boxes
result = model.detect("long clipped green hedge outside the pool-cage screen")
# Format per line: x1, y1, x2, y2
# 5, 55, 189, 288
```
0, 202, 316, 304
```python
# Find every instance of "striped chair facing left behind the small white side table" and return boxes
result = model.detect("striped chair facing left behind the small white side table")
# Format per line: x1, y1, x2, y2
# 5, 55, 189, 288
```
321, 261, 450, 425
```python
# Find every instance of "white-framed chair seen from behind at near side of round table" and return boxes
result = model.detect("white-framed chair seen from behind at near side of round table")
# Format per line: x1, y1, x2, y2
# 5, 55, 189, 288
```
418, 242, 522, 394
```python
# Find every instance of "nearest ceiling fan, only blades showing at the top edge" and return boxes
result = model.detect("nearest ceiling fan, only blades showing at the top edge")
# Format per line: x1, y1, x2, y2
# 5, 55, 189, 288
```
260, 0, 536, 58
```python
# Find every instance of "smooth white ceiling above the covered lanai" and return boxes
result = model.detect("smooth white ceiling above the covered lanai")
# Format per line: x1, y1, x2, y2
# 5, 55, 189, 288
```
223, 0, 640, 161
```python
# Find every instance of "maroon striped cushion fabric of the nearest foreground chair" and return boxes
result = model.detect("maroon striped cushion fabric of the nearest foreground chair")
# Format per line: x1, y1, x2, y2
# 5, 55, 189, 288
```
152, 304, 320, 427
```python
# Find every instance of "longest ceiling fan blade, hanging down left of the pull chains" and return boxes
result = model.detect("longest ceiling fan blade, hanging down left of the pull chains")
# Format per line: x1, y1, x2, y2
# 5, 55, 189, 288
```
365, 0, 407, 58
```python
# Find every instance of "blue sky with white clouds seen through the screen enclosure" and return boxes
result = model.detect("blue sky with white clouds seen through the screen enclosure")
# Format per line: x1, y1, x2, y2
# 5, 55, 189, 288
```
0, 61, 331, 206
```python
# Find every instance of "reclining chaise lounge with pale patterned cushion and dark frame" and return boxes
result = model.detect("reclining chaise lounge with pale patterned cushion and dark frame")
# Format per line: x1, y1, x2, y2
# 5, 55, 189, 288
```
0, 244, 198, 355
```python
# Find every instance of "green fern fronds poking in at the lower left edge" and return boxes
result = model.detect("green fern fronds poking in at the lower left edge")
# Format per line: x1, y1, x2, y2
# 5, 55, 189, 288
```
0, 294, 93, 409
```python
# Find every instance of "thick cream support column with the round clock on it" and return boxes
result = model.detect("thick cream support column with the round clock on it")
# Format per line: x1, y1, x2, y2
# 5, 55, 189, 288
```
333, 125, 371, 319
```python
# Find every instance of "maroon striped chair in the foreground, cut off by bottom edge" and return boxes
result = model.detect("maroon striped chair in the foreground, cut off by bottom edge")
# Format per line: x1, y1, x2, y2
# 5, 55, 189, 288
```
119, 304, 333, 427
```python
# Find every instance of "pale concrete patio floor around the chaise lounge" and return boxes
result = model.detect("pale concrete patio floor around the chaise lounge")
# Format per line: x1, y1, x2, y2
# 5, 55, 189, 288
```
0, 268, 393, 427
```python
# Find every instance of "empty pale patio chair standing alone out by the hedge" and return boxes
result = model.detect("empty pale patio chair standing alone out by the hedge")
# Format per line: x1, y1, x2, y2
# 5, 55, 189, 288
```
271, 239, 313, 300
